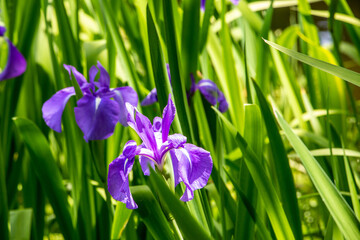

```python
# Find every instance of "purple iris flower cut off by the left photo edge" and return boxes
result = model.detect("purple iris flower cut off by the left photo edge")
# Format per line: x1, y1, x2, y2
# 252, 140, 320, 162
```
0, 26, 26, 81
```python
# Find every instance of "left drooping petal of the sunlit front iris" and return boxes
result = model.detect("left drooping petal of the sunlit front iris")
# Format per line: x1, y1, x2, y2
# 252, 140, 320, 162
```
108, 155, 138, 209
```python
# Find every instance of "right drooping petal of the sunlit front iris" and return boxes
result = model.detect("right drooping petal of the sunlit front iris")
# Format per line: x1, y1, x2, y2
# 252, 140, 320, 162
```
172, 144, 213, 201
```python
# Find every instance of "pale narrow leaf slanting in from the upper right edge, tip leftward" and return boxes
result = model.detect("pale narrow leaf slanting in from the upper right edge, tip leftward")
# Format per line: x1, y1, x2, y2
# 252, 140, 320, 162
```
264, 39, 360, 86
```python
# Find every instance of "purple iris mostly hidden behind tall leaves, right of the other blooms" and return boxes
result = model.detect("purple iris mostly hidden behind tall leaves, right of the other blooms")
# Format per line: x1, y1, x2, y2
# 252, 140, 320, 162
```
141, 64, 229, 112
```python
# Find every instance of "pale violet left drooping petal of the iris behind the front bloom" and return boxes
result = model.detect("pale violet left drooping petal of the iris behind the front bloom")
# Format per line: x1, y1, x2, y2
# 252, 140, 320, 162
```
42, 87, 75, 132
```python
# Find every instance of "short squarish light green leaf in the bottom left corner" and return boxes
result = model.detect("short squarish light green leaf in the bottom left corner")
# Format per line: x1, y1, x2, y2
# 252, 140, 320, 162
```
10, 208, 32, 240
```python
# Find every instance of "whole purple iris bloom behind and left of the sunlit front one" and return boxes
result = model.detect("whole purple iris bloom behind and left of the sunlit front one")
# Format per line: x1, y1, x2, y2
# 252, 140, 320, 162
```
42, 62, 138, 141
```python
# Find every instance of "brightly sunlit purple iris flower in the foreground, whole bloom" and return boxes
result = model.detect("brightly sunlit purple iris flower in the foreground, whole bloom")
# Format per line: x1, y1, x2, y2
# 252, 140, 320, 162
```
108, 95, 213, 209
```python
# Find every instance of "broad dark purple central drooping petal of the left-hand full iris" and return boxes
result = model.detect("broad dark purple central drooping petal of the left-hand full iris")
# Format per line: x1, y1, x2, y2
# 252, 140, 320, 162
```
74, 95, 119, 141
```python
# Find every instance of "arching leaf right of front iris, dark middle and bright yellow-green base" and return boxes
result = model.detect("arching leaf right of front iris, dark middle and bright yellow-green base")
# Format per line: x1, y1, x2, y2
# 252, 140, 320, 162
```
213, 108, 294, 239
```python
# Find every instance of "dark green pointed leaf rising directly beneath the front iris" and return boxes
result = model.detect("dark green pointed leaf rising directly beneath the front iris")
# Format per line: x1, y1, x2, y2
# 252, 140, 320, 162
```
150, 168, 211, 240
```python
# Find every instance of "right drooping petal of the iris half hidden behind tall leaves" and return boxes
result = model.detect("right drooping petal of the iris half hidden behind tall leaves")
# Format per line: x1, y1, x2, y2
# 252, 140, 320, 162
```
197, 79, 228, 112
